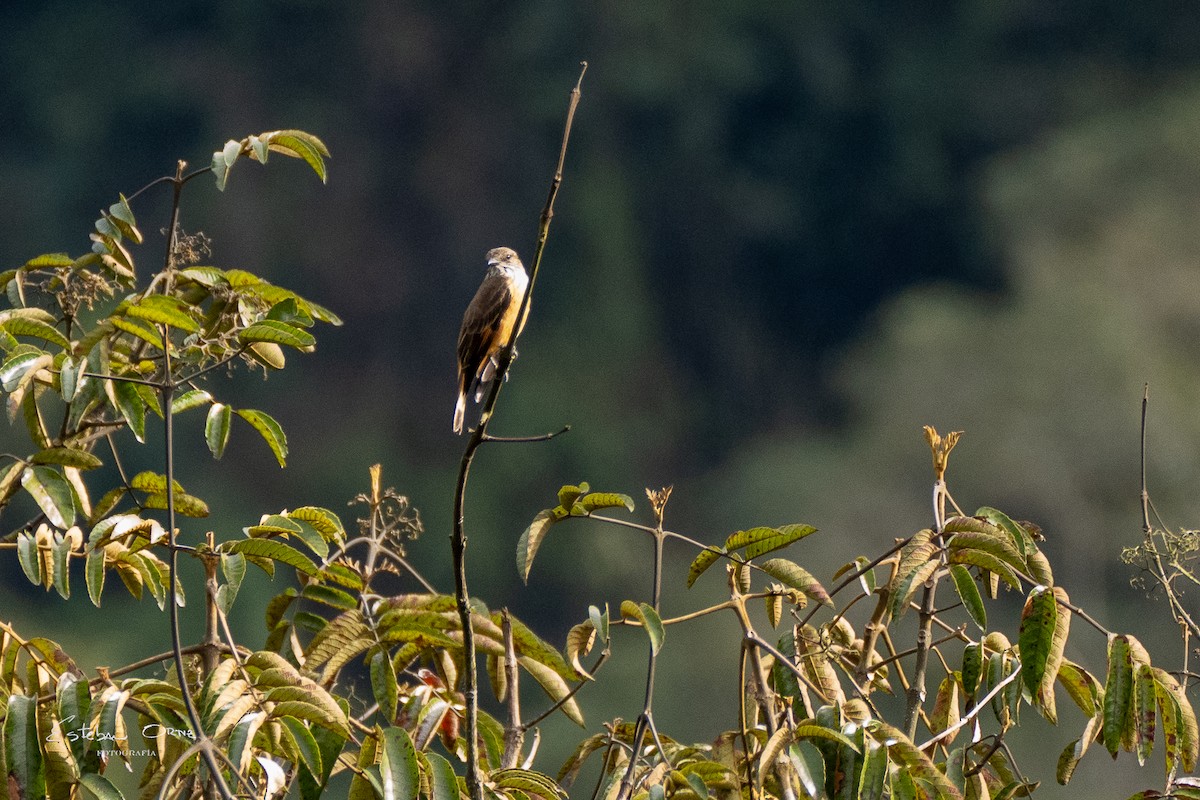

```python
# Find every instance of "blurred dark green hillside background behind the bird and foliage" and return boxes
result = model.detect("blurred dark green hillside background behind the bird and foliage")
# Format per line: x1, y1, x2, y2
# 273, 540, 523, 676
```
0, 0, 1200, 796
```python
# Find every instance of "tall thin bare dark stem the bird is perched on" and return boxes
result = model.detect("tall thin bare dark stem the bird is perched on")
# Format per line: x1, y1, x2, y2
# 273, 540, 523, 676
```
450, 61, 588, 800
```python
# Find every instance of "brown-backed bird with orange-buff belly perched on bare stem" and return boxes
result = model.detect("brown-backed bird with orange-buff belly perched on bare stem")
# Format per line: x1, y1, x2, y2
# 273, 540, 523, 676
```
454, 247, 529, 433
